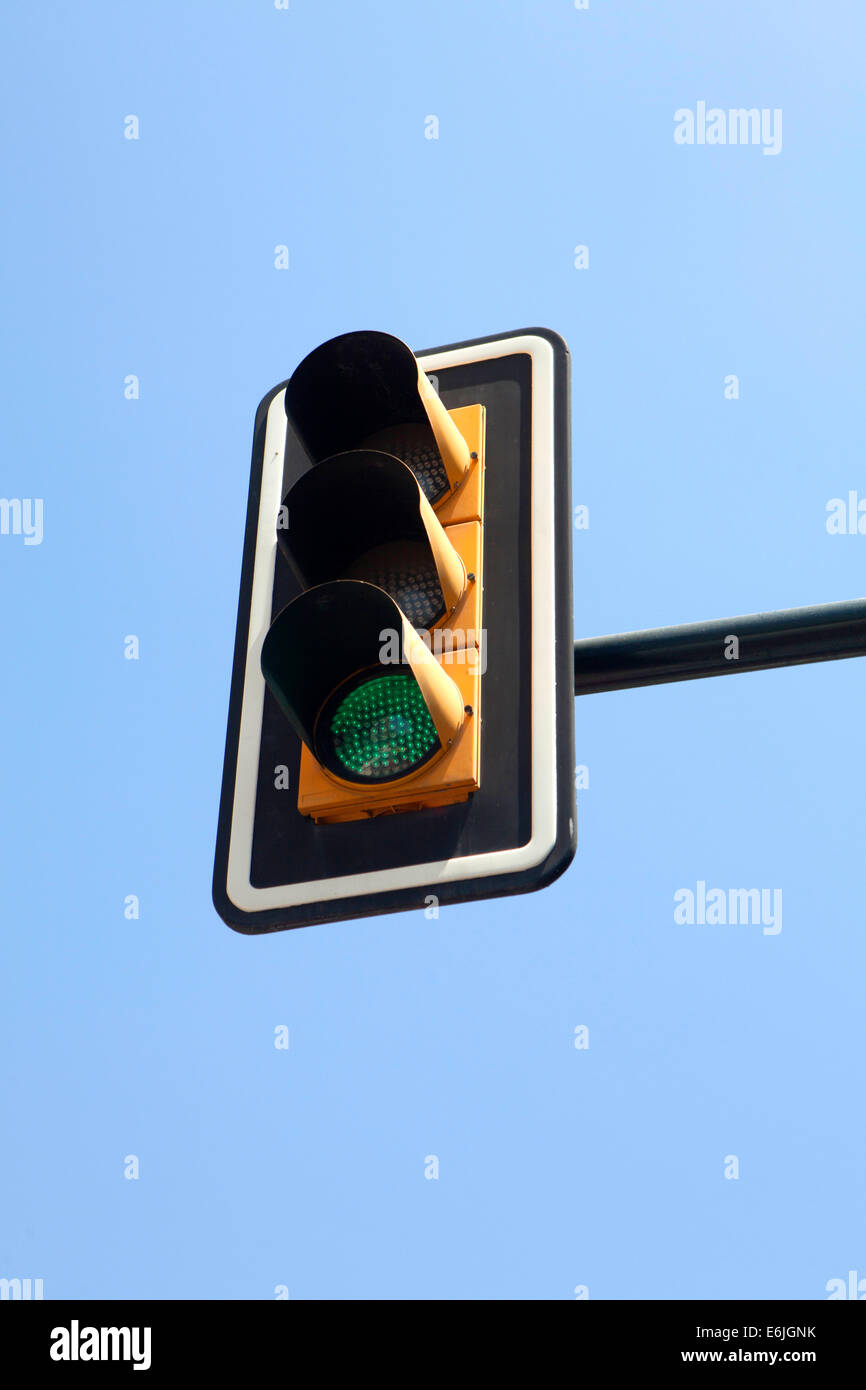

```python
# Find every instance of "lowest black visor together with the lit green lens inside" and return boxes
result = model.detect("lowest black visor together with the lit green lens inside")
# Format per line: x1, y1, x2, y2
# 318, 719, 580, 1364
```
261, 580, 442, 783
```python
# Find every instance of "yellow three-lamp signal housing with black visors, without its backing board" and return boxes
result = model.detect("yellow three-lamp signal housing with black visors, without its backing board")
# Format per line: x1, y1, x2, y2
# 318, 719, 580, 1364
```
261, 334, 485, 823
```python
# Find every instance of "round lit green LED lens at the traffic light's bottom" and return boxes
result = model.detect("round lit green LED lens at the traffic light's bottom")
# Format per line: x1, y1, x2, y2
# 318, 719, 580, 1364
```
329, 671, 439, 780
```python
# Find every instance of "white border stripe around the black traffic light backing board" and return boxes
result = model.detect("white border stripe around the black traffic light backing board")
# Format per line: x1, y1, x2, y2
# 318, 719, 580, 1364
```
227, 334, 556, 912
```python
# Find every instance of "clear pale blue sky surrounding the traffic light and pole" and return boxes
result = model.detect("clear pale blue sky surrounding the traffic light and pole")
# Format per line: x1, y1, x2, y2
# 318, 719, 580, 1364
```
0, 0, 866, 1300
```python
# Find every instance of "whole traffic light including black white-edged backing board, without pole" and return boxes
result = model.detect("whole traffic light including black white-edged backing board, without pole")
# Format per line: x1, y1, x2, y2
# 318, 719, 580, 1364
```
214, 329, 575, 931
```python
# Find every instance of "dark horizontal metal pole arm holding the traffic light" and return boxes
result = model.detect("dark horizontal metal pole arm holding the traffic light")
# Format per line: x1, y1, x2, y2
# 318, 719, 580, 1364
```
574, 599, 866, 695
